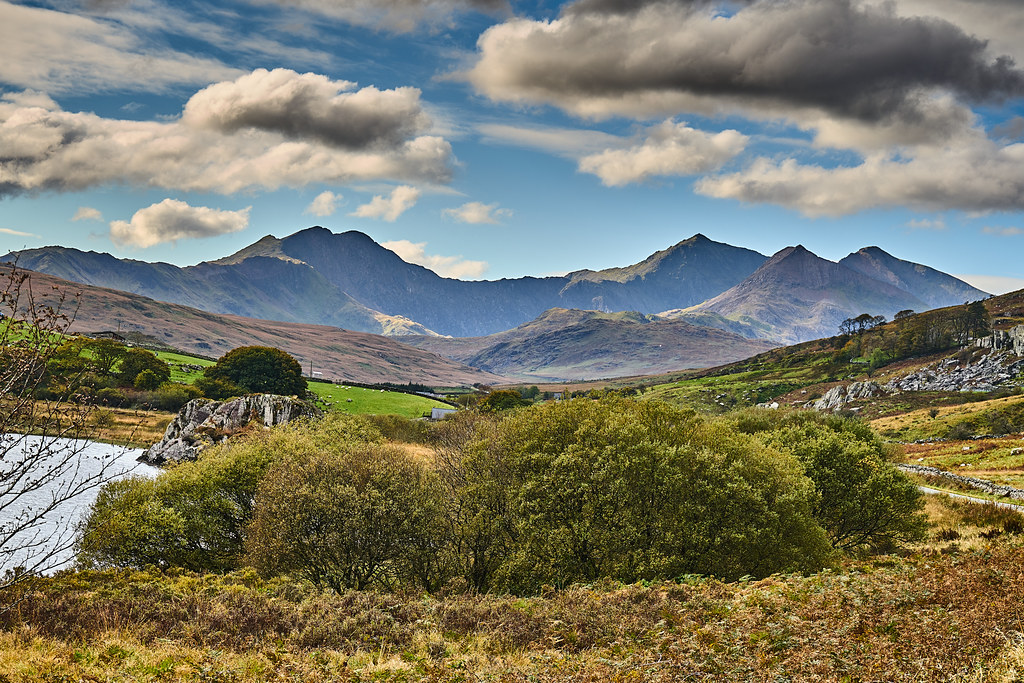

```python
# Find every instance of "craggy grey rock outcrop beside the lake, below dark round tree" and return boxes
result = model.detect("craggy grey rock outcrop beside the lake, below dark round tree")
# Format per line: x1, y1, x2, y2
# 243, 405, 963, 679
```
139, 393, 321, 465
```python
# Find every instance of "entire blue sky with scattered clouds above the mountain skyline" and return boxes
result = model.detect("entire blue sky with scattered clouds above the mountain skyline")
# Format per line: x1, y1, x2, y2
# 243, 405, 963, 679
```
0, 0, 1024, 292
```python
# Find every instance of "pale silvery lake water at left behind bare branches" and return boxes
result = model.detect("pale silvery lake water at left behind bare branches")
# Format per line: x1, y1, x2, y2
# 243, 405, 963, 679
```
0, 434, 160, 575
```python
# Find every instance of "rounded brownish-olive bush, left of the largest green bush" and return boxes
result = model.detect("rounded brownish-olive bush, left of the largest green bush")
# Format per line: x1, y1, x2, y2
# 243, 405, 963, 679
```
246, 444, 444, 592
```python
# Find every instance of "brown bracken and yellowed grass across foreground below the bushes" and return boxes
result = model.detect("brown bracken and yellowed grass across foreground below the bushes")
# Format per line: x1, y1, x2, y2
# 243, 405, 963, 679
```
0, 493, 1024, 683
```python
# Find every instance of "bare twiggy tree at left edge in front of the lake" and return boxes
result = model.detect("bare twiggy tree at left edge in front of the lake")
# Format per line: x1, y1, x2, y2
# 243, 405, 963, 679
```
0, 266, 125, 610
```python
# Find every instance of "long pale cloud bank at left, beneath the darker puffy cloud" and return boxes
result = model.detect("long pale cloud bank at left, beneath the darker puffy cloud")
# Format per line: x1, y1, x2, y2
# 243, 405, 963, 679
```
0, 72, 452, 197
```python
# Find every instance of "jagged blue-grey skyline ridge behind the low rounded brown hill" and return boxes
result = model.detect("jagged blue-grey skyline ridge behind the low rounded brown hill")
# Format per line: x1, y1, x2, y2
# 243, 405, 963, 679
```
2, 226, 984, 350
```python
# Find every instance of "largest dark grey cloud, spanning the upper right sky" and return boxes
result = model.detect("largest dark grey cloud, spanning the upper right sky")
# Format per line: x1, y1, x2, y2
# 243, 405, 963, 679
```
467, 0, 1024, 139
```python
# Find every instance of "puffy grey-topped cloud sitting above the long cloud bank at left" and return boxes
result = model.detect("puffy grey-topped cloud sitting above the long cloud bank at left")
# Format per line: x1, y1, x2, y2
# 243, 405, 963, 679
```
182, 69, 430, 150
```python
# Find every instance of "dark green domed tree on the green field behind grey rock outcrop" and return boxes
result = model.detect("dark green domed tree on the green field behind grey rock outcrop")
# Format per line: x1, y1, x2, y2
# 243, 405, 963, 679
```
204, 346, 306, 396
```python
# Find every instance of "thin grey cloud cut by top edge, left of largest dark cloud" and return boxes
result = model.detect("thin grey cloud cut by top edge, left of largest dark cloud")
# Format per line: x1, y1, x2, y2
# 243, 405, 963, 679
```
244, 0, 509, 33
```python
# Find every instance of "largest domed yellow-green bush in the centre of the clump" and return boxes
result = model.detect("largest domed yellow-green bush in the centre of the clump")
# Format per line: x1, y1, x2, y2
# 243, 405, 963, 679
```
440, 398, 829, 592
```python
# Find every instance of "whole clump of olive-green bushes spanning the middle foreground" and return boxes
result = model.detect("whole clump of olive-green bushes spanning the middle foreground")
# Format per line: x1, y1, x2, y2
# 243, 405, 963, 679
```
81, 396, 923, 593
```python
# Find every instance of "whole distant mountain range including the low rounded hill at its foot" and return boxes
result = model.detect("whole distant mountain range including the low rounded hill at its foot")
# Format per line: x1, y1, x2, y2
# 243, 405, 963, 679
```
0, 226, 986, 381
